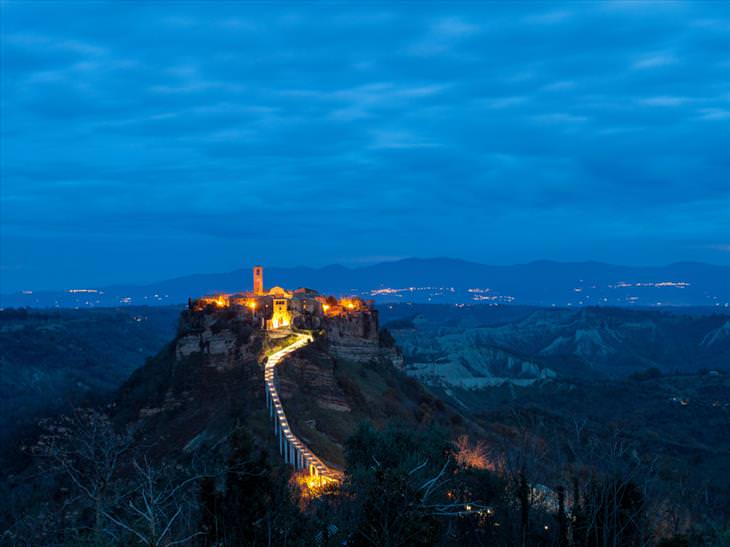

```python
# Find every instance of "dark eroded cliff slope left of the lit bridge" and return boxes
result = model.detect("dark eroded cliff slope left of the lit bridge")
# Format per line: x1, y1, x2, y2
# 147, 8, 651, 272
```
105, 310, 265, 456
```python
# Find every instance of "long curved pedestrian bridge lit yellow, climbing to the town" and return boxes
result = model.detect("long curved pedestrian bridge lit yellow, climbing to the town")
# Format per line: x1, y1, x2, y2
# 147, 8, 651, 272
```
264, 333, 341, 485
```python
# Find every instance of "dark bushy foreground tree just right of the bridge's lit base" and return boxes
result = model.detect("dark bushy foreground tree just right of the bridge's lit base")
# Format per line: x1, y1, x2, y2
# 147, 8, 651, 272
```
343, 424, 488, 547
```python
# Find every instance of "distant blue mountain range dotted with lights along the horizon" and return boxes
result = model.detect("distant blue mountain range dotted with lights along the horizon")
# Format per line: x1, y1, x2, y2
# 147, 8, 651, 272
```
0, 258, 730, 308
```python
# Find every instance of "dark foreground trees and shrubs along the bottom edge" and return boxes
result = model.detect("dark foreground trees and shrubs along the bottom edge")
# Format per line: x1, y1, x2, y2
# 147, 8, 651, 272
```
7, 404, 728, 547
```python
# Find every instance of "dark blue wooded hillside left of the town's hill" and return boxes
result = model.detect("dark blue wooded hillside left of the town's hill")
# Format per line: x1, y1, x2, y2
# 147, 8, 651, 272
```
0, 307, 179, 452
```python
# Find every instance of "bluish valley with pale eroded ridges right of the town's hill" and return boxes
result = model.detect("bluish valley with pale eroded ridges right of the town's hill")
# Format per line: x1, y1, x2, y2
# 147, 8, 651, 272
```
382, 304, 730, 388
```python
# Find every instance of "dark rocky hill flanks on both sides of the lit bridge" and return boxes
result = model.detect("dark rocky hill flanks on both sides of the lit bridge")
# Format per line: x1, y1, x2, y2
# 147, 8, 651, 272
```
116, 310, 458, 466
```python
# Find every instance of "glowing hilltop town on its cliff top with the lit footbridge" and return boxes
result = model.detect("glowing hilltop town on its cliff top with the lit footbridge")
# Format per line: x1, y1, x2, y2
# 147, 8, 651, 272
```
175, 266, 403, 486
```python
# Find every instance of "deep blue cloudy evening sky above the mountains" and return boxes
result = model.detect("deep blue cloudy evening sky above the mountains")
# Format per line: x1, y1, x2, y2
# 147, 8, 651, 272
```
0, 2, 730, 292
